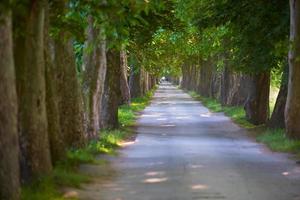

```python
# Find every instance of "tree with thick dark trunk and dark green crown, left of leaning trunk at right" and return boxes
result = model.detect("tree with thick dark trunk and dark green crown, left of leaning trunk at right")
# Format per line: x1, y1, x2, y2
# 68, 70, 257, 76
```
178, 0, 288, 124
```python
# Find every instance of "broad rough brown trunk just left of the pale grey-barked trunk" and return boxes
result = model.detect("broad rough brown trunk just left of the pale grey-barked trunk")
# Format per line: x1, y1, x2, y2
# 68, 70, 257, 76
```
50, 1, 86, 148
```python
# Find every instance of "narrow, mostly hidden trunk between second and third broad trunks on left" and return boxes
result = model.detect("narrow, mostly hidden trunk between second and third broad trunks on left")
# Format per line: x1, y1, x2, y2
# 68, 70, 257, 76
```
44, 1, 65, 164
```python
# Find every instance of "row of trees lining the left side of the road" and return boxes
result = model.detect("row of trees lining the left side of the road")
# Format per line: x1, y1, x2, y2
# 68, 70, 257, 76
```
0, 0, 176, 200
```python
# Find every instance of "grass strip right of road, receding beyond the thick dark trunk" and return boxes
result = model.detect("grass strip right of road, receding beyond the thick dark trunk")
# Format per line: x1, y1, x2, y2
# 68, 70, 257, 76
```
188, 91, 255, 128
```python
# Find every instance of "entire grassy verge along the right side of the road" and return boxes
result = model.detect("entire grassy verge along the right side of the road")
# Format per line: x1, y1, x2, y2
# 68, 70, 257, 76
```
188, 91, 300, 157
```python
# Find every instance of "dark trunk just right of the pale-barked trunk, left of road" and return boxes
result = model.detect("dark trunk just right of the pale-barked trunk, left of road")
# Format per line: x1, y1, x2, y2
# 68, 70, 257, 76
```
100, 50, 121, 129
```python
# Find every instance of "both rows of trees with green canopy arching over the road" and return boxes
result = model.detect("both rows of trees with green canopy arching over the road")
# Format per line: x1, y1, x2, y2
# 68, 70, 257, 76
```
0, 0, 300, 200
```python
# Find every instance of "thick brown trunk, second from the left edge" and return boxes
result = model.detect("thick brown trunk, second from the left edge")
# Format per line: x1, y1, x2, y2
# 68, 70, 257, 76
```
15, 0, 52, 179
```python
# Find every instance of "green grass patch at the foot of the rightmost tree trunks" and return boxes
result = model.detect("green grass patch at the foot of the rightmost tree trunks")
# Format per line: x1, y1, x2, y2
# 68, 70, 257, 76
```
257, 129, 300, 154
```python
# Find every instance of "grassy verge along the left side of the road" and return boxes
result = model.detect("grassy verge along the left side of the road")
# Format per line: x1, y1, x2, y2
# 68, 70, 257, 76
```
21, 89, 155, 200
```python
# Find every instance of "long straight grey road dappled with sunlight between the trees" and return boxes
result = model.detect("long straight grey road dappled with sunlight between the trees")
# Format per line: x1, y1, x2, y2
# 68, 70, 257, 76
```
72, 82, 300, 200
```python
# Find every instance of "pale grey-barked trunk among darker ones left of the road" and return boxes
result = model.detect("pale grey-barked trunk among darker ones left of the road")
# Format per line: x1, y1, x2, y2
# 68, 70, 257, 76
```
83, 17, 106, 139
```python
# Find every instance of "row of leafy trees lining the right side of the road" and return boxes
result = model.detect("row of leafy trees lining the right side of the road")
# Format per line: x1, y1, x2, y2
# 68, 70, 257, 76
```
166, 0, 300, 139
